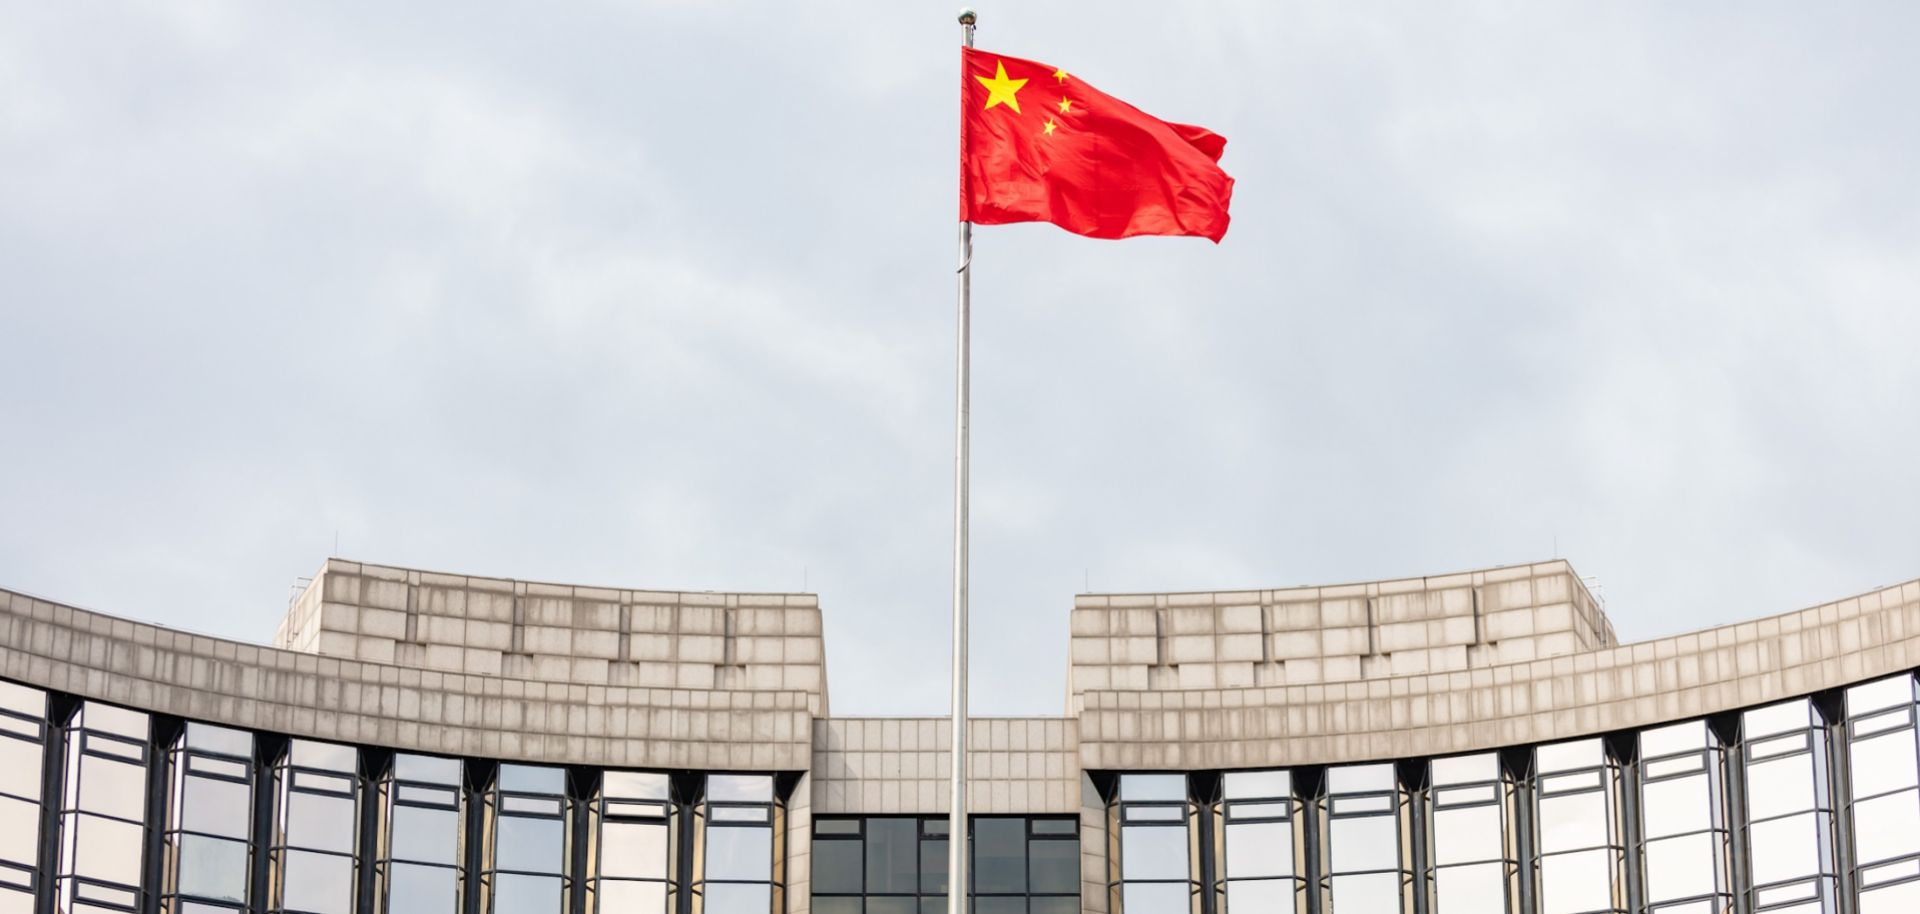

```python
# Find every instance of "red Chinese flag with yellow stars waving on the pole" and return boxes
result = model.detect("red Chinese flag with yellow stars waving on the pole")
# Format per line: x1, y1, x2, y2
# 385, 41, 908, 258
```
960, 48, 1233, 242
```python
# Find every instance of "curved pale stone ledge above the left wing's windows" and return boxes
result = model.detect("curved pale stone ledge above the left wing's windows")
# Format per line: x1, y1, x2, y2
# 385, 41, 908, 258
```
0, 589, 816, 770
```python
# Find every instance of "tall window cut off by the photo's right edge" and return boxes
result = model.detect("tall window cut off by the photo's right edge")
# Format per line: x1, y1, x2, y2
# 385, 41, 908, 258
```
1845, 674, 1920, 914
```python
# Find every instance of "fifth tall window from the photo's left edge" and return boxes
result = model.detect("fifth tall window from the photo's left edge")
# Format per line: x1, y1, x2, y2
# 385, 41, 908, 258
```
376, 755, 465, 914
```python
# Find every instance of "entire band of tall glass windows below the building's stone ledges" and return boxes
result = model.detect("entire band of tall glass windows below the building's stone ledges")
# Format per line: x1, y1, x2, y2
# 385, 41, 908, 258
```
15, 676, 1920, 914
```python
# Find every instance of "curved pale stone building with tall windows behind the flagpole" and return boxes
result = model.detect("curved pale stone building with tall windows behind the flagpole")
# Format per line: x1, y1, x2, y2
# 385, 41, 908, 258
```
0, 561, 1920, 914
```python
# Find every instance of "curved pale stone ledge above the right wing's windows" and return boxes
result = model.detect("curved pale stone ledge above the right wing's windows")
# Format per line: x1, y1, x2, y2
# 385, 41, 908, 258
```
1079, 580, 1920, 770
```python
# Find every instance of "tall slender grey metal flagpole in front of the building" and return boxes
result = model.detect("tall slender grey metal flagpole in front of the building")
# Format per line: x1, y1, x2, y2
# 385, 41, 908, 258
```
947, 8, 979, 914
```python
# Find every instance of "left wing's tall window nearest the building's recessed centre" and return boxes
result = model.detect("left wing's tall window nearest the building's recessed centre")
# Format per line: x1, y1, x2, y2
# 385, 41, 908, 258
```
695, 774, 785, 914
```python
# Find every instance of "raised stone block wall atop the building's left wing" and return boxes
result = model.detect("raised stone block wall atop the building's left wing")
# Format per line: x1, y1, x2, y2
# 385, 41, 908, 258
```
275, 559, 828, 714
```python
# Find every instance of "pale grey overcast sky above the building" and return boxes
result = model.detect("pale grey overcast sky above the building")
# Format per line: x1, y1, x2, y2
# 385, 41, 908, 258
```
0, 0, 1920, 714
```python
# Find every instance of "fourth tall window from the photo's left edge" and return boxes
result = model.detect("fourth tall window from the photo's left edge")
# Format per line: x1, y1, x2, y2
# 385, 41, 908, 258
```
269, 739, 359, 914
